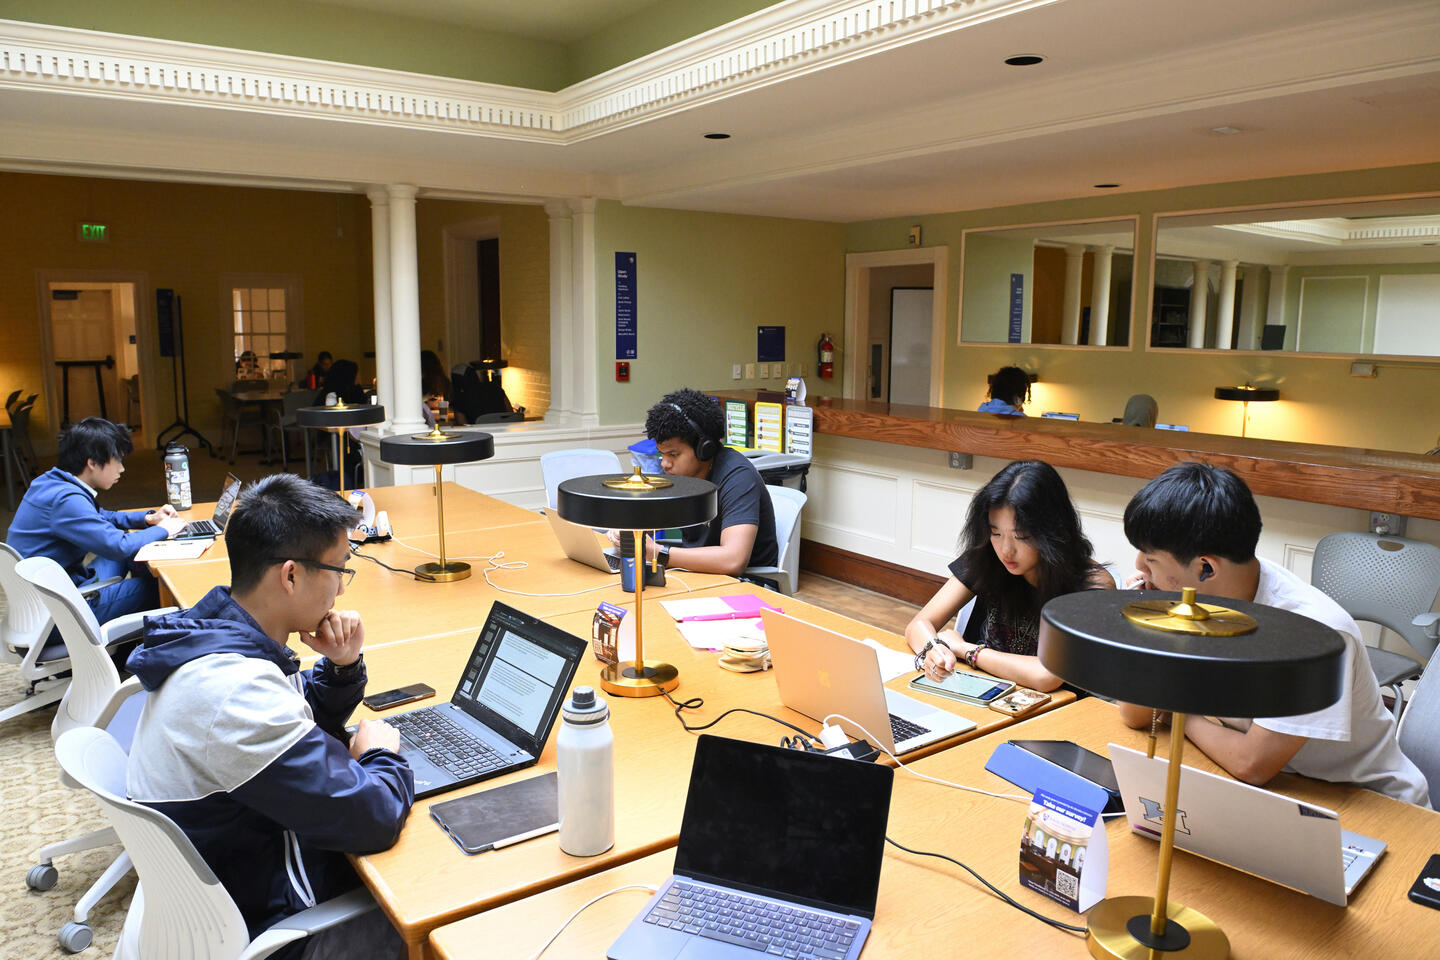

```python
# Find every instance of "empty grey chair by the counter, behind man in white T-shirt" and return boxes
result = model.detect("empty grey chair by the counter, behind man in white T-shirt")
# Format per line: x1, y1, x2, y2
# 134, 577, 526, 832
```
1310, 531, 1440, 717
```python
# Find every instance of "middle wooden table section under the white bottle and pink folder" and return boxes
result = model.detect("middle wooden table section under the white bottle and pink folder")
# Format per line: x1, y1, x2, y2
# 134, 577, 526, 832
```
353, 583, 1071, 957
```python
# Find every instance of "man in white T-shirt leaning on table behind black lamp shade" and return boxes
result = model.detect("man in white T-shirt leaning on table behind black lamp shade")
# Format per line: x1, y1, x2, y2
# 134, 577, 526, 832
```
1120, 462, 1428, 806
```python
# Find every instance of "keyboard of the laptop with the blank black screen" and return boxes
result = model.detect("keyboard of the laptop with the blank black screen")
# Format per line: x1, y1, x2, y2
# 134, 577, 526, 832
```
645, 879, 860, 960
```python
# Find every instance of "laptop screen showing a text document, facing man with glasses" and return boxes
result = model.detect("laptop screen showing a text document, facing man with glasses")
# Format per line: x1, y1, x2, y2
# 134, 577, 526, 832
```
451, 602, 586, 754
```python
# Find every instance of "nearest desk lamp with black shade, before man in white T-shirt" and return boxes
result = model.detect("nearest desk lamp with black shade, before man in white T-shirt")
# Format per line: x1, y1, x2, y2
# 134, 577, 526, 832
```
1040, 587, 1345, 960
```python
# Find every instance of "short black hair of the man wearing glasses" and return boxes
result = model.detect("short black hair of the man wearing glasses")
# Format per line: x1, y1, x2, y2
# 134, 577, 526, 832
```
225, 474, 360, 592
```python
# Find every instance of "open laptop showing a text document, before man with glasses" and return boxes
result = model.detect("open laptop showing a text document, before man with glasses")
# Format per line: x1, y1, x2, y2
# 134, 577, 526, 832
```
383, 602, 586, 799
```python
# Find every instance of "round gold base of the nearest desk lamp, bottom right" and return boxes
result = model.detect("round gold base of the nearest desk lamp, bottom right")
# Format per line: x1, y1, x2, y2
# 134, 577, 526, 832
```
1086, 897, 1230, 960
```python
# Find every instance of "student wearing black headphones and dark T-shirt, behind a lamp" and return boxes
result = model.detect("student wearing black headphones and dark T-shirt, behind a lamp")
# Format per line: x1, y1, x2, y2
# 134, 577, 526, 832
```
611, 390, 779, 576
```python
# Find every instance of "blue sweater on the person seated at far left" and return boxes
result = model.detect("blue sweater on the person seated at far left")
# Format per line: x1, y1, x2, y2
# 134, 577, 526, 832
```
7, 466, 168, 584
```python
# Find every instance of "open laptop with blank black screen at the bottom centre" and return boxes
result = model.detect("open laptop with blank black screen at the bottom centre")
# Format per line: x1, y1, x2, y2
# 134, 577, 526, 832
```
605, 734, 894, 960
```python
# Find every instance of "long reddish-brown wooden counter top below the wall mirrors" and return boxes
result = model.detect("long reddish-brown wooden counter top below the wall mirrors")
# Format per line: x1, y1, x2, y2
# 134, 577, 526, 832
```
714, 390, 1440, 520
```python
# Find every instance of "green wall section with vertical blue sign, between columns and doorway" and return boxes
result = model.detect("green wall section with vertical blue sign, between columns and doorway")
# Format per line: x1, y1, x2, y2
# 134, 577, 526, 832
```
595, 200, 845, 423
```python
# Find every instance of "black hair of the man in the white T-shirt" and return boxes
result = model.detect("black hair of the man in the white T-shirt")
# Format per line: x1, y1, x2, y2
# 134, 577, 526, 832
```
1125, 461, 1260, 563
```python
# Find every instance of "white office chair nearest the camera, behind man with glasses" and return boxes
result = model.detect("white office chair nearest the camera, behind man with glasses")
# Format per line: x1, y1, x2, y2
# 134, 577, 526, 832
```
55, 727, 374, 960
